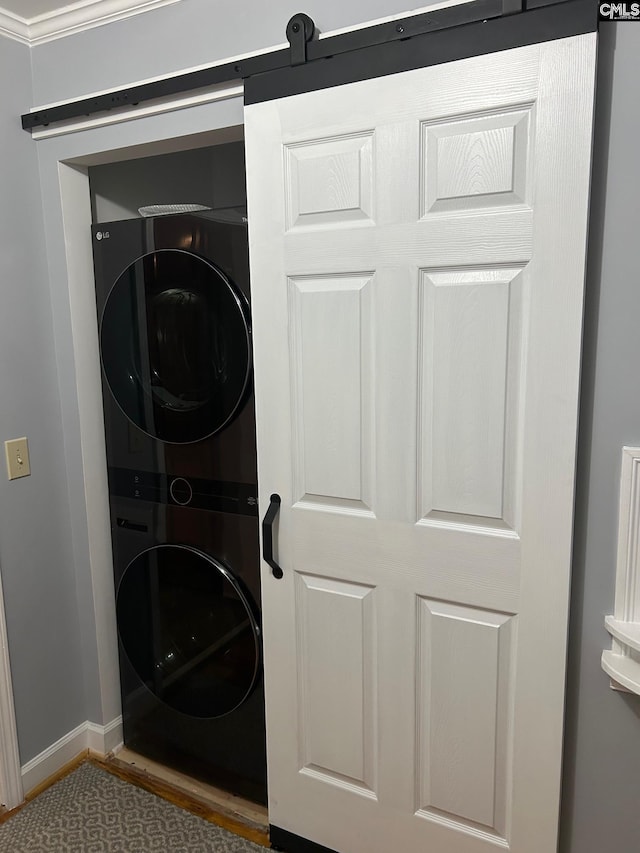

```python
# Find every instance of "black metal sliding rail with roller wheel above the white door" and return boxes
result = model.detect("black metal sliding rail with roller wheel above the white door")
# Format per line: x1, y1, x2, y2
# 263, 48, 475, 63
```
21, 0, 598, 131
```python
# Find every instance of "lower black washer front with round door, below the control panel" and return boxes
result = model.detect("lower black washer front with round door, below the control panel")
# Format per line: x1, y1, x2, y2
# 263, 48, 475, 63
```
111, 496, 266, 803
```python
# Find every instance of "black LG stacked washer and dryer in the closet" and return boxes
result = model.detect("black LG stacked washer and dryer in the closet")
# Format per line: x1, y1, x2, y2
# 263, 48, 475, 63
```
93, 209, 266, 802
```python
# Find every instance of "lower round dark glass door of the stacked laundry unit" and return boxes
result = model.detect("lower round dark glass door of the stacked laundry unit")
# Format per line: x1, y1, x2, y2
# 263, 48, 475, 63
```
116, 545, 261, 718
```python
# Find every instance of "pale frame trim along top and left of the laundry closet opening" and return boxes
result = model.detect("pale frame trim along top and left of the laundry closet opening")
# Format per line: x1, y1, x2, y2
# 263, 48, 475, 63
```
31, 92, 248, 781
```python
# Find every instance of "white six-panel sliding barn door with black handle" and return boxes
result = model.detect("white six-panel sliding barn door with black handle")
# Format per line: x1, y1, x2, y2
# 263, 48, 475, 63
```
246, 34, 596, 853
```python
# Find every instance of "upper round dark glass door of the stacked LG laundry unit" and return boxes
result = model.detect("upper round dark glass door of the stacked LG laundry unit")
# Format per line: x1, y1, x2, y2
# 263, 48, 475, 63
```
100, 249, 251, 443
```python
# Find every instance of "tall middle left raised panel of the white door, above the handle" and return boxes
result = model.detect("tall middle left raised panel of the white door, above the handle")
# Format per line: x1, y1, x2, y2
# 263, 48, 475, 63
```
289, 273, 374, 512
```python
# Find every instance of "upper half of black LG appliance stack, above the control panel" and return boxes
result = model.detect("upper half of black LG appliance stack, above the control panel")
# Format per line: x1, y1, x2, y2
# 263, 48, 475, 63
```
93, 210, 257, 490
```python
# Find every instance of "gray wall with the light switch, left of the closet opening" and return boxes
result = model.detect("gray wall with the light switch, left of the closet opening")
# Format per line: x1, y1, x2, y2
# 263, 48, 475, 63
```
0, 39, 86, 763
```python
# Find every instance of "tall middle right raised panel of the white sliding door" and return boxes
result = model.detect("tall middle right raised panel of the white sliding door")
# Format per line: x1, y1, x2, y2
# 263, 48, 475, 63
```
418, 268, 527, 527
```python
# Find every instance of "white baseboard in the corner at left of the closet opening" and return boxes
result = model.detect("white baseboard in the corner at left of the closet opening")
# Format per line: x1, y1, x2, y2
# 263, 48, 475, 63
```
21, 717, 122, 794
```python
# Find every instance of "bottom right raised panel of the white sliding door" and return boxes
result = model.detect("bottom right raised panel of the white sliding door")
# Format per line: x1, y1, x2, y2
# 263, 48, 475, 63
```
417, 599, 515, 838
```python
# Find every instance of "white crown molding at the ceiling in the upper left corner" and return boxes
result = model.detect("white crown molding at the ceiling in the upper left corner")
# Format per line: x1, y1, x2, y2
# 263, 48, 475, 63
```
0, 0, 180, 47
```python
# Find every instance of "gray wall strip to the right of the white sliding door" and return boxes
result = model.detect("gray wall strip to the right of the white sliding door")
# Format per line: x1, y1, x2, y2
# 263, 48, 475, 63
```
560, 24, 640, 853
